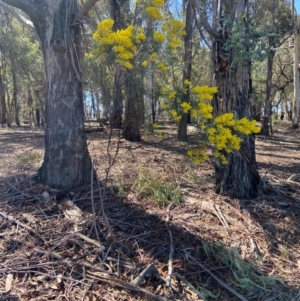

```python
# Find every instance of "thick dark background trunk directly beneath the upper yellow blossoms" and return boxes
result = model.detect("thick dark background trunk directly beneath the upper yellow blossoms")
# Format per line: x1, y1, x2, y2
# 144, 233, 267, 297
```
123, 71, 141, 142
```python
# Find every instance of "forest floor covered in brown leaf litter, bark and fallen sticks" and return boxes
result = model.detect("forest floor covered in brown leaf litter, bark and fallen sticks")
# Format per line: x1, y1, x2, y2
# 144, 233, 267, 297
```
0, 121, 300, 301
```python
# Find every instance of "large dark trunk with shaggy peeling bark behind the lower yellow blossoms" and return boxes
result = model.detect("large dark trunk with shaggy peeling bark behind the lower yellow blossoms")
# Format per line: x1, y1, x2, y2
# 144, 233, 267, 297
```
193, 0, 260, 199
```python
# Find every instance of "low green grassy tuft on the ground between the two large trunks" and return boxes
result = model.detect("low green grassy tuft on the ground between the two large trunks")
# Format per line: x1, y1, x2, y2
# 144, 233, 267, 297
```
133, 169, 182, 206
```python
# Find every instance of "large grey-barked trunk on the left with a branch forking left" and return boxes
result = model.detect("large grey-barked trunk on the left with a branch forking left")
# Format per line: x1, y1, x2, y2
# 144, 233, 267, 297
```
3, 0, 92, 188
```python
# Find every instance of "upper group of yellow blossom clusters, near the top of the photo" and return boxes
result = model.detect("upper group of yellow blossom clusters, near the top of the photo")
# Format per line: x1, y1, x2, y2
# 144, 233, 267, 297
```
89, 0, 186, 72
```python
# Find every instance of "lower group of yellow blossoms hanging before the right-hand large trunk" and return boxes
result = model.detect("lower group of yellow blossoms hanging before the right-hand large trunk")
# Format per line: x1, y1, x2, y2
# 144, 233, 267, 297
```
160, 82, 260, 165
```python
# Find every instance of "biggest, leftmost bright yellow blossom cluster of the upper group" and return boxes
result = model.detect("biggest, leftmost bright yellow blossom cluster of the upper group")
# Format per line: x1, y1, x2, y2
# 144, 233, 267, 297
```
93, 19, 146, 69
